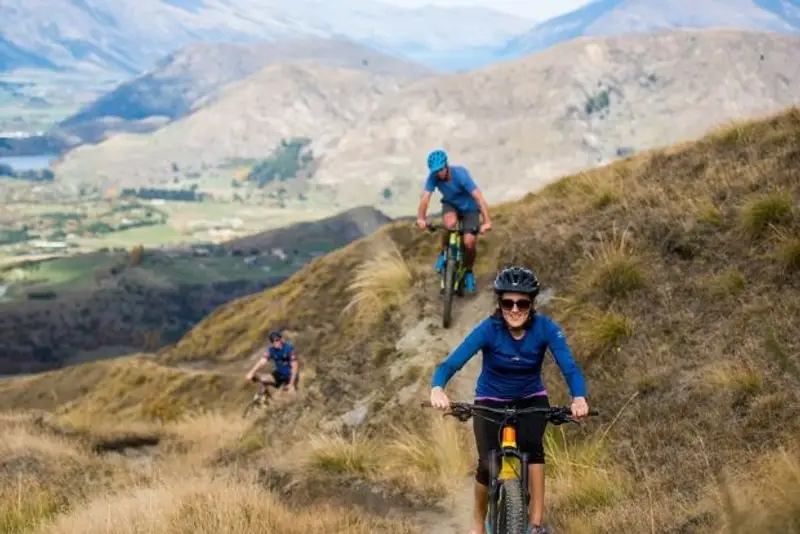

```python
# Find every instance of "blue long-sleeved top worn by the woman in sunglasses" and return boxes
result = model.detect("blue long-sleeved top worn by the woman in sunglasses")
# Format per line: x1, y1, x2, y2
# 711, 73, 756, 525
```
432, 314, 586, 400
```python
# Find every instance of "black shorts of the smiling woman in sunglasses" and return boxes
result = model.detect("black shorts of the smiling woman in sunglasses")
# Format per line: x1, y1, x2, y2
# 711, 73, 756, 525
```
473, 395, 550, 486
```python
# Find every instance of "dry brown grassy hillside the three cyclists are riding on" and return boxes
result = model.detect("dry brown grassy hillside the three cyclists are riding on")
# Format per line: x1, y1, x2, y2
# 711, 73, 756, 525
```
0, 108, 800, 534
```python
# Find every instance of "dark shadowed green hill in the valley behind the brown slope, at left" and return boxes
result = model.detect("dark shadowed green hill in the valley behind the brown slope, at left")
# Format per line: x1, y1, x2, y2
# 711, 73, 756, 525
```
0, 208, 390, 376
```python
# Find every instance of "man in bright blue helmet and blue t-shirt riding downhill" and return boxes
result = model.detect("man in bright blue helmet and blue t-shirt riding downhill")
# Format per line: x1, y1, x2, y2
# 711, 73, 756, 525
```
417, 150, 492, 291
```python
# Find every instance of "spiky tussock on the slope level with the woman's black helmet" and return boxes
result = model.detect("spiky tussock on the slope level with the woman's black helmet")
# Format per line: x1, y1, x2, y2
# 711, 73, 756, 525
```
581, 228, 645, 298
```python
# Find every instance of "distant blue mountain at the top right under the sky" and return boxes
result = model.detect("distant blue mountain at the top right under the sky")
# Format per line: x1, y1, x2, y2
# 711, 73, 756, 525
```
499, 0, 800, 58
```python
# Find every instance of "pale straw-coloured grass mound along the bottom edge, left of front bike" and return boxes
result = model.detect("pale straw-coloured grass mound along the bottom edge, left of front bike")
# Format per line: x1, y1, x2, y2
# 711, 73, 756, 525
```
36, 477, 415, 534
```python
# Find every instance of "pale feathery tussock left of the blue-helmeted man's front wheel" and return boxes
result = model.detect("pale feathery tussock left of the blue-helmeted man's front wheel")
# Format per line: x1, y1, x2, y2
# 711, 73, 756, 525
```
342, 239, 414, 323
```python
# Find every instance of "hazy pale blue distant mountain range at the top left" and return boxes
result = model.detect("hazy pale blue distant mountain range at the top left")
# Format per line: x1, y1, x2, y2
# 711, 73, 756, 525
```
0, 0, 532, 75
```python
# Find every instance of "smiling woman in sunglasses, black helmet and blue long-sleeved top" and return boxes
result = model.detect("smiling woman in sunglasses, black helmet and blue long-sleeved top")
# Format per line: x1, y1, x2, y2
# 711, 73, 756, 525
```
431, 266, 589, 534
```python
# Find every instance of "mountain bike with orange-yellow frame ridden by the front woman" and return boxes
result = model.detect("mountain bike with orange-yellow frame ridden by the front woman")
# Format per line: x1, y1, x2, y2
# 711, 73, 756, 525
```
422, 401, 599, 534
